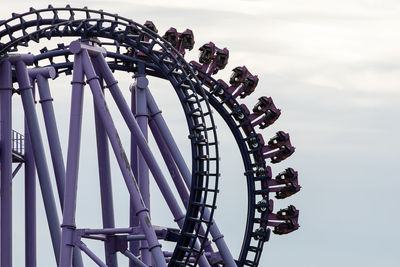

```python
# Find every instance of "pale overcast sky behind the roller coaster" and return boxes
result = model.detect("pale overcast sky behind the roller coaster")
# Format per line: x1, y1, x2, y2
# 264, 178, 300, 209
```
0, 0, 400, 267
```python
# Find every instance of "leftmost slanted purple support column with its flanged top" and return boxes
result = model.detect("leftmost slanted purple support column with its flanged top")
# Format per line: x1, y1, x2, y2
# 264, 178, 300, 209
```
13, 54, 61, 263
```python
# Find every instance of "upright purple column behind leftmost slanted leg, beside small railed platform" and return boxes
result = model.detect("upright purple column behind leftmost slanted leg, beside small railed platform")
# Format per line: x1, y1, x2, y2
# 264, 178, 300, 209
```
24, 101, 36, 267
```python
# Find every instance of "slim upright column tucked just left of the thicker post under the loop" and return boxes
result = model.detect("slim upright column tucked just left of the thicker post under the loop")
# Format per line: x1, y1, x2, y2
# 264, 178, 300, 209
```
129, 86, 140, 267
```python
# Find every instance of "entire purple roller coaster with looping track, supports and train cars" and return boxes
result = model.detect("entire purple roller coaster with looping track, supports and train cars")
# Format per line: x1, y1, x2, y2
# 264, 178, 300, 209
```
0, 6, 300, 267
